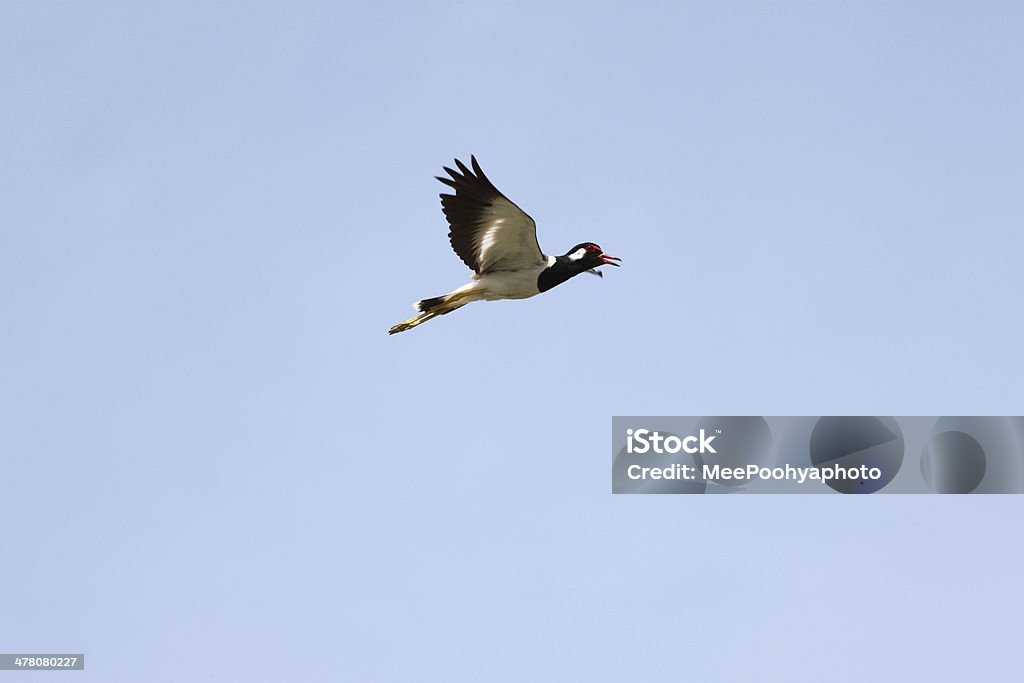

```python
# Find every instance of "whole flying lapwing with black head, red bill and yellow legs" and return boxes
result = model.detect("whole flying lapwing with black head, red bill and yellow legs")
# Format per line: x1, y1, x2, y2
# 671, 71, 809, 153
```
388, 157, 622, 335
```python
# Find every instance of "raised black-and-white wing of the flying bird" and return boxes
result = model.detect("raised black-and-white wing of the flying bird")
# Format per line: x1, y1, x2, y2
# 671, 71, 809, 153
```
437, 157, 547, 275
